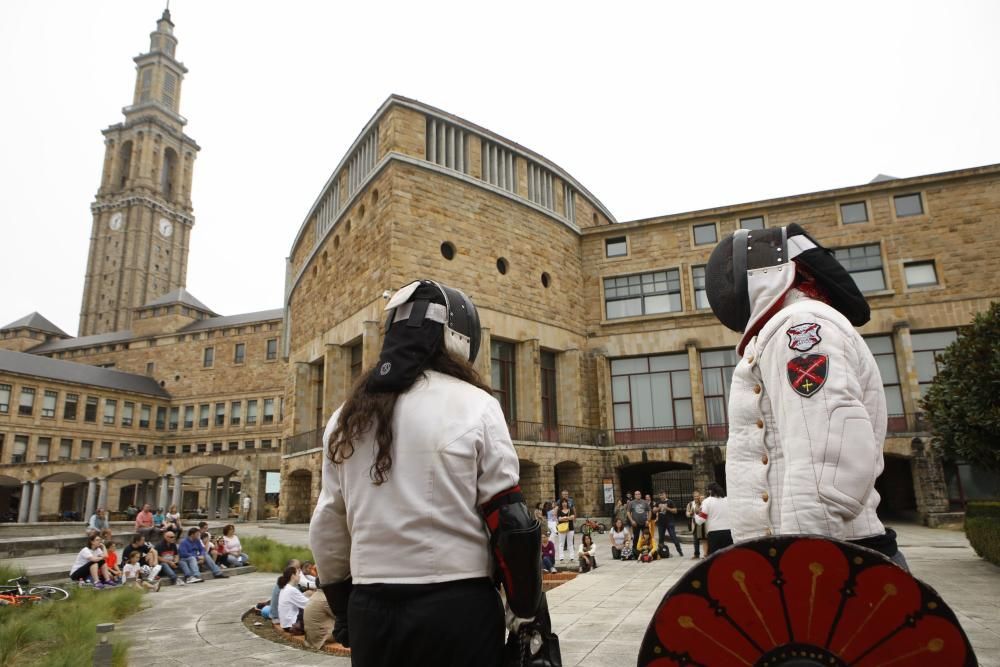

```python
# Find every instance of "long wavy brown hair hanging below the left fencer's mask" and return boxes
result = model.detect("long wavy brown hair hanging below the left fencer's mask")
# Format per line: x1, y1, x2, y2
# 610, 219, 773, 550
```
327, 346, 492, 486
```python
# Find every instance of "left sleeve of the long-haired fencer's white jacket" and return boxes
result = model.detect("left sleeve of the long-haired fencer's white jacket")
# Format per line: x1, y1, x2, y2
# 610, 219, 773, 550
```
309, 410, 351, 583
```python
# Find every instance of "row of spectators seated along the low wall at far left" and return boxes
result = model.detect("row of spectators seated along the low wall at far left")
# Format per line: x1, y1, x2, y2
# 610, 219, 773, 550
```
70, 520, 250, 590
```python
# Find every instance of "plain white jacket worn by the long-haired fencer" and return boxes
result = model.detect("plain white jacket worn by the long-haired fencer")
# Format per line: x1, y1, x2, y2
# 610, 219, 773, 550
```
309, 371, 519, 584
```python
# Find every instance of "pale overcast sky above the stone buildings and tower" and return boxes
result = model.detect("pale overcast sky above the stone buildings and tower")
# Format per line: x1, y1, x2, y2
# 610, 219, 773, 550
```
0, 0, 1000, 334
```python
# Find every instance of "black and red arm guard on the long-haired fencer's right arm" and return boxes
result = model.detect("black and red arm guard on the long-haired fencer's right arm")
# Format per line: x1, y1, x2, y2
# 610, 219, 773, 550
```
480, 486, 542, 618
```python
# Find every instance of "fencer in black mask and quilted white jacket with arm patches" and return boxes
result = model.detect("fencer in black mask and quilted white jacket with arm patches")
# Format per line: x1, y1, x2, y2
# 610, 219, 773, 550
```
706, 224, 906, 568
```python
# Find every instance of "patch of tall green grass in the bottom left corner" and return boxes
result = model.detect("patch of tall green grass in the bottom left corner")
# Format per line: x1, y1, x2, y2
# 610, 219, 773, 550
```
0, 567, 143, 667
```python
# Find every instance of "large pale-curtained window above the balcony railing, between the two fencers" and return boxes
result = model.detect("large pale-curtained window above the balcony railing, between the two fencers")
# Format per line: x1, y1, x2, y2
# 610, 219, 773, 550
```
611, 353, 694, 441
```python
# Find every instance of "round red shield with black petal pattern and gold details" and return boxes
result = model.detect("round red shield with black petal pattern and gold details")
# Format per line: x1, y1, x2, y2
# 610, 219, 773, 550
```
638, 536, 977, 667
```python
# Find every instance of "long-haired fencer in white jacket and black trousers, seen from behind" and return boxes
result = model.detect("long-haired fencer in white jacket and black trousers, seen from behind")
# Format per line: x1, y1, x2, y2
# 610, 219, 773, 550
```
309, 280, 550, 667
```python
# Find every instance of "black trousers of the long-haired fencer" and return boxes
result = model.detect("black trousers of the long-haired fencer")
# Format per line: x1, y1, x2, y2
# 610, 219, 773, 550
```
347, 578, 504, 667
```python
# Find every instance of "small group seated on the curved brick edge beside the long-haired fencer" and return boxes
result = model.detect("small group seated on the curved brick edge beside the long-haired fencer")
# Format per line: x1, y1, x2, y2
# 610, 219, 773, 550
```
257, 559, 348, 649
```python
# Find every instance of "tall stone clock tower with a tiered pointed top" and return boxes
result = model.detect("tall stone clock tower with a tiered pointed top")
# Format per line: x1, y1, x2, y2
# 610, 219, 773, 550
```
79, 10, 199, 336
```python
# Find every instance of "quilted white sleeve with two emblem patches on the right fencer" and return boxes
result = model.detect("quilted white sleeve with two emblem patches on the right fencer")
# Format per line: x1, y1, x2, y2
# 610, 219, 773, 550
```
761, 311, 881, 537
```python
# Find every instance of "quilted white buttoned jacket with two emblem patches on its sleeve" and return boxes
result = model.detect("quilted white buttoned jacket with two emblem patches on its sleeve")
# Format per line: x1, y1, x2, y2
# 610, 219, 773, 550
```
726, 290, 886, 542
